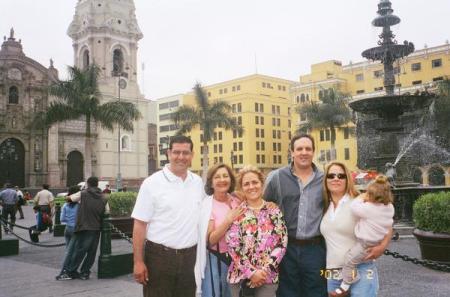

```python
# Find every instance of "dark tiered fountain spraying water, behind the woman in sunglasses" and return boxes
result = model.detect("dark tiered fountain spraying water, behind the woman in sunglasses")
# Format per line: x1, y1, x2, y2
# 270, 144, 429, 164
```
349, 0, 449, 222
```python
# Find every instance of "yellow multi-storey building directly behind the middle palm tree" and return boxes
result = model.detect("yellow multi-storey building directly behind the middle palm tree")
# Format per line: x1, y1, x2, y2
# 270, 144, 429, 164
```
163, 74, 295, 173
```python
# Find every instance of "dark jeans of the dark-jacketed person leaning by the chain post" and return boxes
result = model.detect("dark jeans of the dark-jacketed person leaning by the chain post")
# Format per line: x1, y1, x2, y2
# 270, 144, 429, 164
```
63, 230, 100, 275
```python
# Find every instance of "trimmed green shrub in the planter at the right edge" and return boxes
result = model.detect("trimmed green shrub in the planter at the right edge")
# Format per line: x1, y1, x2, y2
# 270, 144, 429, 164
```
413, 192, 450, 233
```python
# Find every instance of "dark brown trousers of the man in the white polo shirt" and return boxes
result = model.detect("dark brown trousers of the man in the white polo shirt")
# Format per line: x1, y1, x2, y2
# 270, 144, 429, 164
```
144, 241, 197, 297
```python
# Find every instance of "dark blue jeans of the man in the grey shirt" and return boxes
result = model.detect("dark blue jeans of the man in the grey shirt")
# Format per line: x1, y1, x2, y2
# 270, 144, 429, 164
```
277, 241, 328, 297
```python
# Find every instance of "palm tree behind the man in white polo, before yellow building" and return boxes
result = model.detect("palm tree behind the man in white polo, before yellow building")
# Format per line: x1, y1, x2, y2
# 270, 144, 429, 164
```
173, 83, 244, 180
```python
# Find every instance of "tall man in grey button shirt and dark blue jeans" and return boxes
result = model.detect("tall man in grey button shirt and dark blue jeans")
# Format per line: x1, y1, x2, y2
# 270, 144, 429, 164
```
264, 134, 328, 297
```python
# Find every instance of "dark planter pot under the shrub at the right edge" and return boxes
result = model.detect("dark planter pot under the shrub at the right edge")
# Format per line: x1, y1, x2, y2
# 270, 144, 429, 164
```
413, 229, 450, 264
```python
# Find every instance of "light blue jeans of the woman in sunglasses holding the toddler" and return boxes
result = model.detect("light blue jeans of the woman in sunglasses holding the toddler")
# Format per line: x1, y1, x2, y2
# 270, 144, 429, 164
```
328, 261, 379, 297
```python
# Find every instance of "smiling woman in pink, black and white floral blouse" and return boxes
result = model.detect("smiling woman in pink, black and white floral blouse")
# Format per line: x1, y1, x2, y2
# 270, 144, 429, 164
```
226, 166, 287, 297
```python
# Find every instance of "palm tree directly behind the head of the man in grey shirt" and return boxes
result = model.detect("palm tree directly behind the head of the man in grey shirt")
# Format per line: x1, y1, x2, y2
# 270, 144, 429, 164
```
296, 88, 352, 159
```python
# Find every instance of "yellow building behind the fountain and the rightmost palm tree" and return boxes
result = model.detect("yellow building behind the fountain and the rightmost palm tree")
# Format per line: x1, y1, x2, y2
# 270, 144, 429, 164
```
291, 42, 450, 182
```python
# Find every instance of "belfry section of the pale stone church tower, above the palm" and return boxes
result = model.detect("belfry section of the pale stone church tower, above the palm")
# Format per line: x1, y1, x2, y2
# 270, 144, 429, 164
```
67, 0, 143, 85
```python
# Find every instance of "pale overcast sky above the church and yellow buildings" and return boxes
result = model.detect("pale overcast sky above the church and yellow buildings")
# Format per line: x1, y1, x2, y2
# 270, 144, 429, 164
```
0, 0, 450, 99
